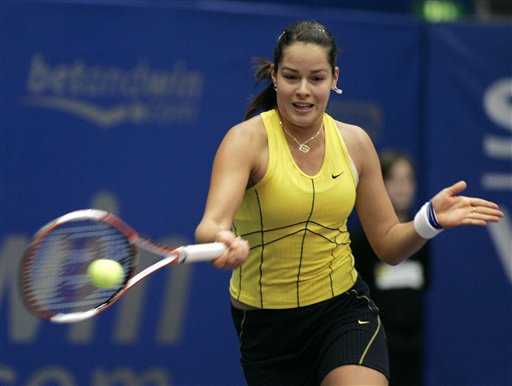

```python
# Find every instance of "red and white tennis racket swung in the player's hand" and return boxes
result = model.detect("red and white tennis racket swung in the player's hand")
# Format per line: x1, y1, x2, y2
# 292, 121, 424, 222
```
21, 209, 225, 323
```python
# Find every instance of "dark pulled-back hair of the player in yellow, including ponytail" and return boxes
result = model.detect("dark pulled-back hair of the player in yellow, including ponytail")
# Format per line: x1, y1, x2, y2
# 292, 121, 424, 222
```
244, 21, 338, 120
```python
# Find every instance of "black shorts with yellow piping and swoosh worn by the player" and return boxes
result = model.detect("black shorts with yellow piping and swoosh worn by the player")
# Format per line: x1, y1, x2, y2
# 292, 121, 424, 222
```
231, 278, 389, 386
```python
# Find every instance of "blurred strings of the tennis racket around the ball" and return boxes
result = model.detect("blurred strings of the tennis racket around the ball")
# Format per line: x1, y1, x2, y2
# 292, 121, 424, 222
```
23, 220, 135, 314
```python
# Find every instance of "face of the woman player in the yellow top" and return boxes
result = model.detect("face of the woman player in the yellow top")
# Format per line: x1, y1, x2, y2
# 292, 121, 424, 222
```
273, 43, 339, 130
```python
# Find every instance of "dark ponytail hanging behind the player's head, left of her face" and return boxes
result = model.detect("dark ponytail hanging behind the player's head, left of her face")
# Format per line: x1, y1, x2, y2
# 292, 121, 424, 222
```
244, 57, 277, 121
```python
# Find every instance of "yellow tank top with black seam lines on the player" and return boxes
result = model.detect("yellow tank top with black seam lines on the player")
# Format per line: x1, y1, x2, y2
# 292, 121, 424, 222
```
230, 110, 357, 308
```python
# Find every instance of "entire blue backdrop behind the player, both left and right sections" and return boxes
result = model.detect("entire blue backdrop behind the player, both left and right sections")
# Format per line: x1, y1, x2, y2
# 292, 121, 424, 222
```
0, 2, 512, 386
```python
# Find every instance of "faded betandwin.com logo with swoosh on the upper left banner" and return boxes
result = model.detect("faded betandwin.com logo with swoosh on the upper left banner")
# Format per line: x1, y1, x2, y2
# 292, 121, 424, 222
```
25, 53, 204, 128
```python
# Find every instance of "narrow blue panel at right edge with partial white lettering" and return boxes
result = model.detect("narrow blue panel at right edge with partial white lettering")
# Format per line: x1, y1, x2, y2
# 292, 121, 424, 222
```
425, 24, 512, 385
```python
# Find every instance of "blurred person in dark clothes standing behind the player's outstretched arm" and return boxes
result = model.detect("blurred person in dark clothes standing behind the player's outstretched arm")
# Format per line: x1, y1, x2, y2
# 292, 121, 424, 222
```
351, 150, 429, 386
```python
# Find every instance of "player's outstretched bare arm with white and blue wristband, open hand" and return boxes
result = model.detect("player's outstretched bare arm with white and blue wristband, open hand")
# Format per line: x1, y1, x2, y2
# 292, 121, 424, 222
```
352, 126, 503, 265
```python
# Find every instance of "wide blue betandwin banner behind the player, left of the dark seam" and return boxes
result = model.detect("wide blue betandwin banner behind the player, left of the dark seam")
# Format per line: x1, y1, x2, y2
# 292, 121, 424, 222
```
0, 2, 420, 386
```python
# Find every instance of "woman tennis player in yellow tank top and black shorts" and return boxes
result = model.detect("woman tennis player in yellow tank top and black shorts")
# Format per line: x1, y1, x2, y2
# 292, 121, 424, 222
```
196, 21, 502, 386
